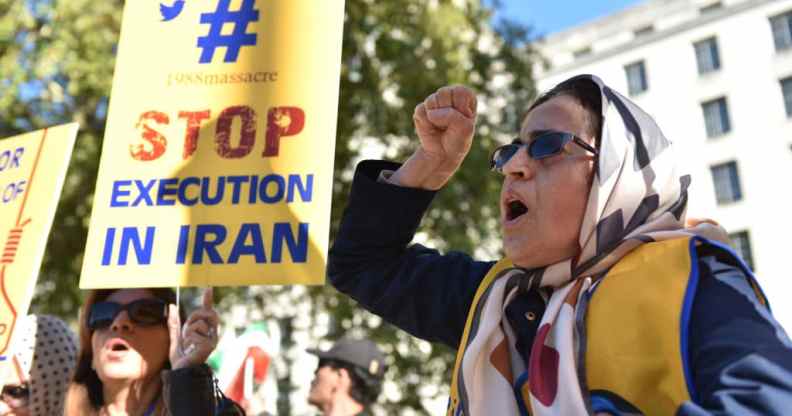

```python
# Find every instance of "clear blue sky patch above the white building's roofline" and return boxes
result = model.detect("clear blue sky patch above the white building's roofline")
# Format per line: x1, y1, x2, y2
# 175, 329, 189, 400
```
486, 0, 646, 36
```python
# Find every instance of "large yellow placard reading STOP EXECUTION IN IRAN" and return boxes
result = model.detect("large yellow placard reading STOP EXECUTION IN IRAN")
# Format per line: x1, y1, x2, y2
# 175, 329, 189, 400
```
80, 0, 344, 288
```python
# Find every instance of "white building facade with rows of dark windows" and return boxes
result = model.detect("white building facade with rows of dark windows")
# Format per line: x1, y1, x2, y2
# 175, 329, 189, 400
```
535, 0, 792, 332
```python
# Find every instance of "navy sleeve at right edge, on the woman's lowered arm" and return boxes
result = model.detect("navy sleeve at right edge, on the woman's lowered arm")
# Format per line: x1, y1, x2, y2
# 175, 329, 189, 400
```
677, 245, 792, 416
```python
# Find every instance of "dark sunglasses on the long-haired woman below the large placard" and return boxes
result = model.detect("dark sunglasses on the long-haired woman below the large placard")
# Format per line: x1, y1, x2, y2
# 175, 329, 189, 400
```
88, 299, 168, 330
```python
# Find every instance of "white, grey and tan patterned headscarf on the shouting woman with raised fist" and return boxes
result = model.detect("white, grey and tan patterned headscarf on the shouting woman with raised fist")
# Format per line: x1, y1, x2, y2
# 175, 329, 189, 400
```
453, 75, 723, 416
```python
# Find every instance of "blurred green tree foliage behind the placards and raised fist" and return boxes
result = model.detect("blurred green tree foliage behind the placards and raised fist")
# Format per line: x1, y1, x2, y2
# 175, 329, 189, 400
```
0, 0, 535, 414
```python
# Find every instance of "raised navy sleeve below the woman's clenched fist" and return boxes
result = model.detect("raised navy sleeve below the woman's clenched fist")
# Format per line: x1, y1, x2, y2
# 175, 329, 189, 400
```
327, 161, 494, 348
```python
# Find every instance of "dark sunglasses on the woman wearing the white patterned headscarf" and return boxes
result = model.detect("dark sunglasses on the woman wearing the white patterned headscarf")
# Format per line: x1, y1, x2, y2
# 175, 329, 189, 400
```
490, 131, 597, 173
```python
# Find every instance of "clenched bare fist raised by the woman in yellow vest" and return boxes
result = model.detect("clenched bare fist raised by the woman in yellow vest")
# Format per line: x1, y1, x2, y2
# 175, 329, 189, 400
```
390, 85, 476, 190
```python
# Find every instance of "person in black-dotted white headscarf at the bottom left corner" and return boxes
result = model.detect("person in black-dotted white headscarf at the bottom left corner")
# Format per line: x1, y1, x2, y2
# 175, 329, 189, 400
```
0, 315, 77, 416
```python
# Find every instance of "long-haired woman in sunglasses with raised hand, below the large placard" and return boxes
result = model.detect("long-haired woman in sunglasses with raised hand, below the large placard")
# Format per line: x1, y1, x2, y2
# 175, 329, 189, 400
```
65, 288, 244, 416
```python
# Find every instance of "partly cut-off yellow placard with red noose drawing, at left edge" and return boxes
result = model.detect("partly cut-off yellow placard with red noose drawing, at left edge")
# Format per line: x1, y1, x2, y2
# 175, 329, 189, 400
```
0, 123, 78, 361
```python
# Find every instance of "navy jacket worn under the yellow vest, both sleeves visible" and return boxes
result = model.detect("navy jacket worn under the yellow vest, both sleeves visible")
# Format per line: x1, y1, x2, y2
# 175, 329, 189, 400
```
328, 161, 792, 416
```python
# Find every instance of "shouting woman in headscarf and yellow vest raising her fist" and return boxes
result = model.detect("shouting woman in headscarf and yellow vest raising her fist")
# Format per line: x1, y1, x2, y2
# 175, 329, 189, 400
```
328, 75, 792, 416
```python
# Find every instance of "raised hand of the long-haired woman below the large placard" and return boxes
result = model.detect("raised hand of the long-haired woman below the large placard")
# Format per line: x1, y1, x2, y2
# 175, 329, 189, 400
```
168, 287, 220, 369
